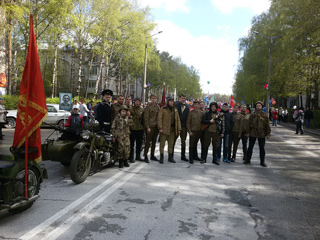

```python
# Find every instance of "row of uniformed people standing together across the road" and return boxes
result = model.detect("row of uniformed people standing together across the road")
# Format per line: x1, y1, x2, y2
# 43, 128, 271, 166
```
95, 89, 271, 168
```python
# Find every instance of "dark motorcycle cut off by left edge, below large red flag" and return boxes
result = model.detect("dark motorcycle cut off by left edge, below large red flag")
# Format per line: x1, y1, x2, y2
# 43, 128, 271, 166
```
0, 146, 48, 213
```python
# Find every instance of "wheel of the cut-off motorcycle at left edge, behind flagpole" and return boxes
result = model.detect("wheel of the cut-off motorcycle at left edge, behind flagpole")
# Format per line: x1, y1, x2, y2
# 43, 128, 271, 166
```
9, 167, 40, 213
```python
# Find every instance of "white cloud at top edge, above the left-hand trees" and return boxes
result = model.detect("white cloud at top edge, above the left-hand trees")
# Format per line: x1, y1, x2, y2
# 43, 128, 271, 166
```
139, 0, 189, 12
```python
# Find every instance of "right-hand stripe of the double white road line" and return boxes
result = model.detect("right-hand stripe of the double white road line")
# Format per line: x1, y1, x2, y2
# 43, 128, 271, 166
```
45, 164, 146, 240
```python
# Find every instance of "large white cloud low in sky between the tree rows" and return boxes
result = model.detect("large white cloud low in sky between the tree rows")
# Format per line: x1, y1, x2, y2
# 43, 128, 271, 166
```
156, 20, 238, 94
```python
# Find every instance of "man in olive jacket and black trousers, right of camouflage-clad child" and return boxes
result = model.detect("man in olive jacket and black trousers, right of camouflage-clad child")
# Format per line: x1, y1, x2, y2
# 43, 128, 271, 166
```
129, 97, 145, 163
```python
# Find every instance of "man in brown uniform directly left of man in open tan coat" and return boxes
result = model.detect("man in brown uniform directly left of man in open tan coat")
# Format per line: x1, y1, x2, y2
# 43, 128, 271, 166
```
144, 94, 160, 162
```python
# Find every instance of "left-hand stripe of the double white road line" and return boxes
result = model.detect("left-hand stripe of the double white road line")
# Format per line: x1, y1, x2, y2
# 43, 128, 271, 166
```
19, 164, 145, 240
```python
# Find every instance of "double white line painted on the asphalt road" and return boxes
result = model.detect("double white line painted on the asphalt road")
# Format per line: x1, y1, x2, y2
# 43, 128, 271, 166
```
19, 164, 146, 240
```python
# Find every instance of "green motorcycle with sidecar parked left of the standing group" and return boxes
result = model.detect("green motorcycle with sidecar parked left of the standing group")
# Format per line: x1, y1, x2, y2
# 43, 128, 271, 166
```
42, 124, 116, 184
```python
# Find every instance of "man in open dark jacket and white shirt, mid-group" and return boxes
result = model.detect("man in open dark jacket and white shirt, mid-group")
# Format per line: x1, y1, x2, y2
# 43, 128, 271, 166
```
175, 93, 190, 161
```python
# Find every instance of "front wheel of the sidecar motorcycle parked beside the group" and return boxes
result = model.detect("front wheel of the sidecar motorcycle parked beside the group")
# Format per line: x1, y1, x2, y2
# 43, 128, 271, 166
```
70, 148, 92, 184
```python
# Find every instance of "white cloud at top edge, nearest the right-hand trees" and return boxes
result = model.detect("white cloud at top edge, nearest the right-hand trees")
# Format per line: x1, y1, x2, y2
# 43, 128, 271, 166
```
211, 0, 271, 14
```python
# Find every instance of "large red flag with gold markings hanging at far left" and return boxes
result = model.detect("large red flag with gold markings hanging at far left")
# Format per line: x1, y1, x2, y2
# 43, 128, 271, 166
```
13, 15, 48, 163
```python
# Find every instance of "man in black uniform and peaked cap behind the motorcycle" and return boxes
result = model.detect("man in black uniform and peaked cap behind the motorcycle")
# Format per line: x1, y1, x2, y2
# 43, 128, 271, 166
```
97, 89, 113, 133
